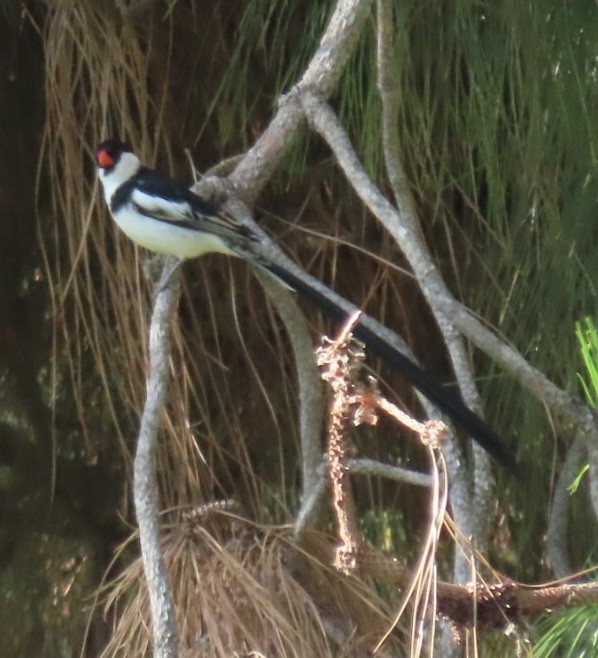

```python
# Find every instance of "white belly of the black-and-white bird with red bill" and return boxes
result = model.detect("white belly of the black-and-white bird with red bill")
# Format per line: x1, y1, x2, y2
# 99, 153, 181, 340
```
114, 206, 236, 258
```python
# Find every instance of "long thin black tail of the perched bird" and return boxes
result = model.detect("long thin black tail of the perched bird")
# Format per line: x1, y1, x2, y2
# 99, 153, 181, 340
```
260, 262, 518, 471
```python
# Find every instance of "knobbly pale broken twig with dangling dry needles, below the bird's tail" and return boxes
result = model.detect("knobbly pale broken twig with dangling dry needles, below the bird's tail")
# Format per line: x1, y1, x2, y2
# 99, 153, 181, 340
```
317, 314, 449, 656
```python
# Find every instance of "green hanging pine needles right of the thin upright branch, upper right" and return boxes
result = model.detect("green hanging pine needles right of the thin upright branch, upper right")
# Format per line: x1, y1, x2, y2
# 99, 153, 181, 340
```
372, 0, 598, 579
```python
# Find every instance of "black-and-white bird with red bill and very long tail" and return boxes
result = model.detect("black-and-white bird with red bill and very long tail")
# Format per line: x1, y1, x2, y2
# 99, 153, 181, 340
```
95, 138, 518, 472
